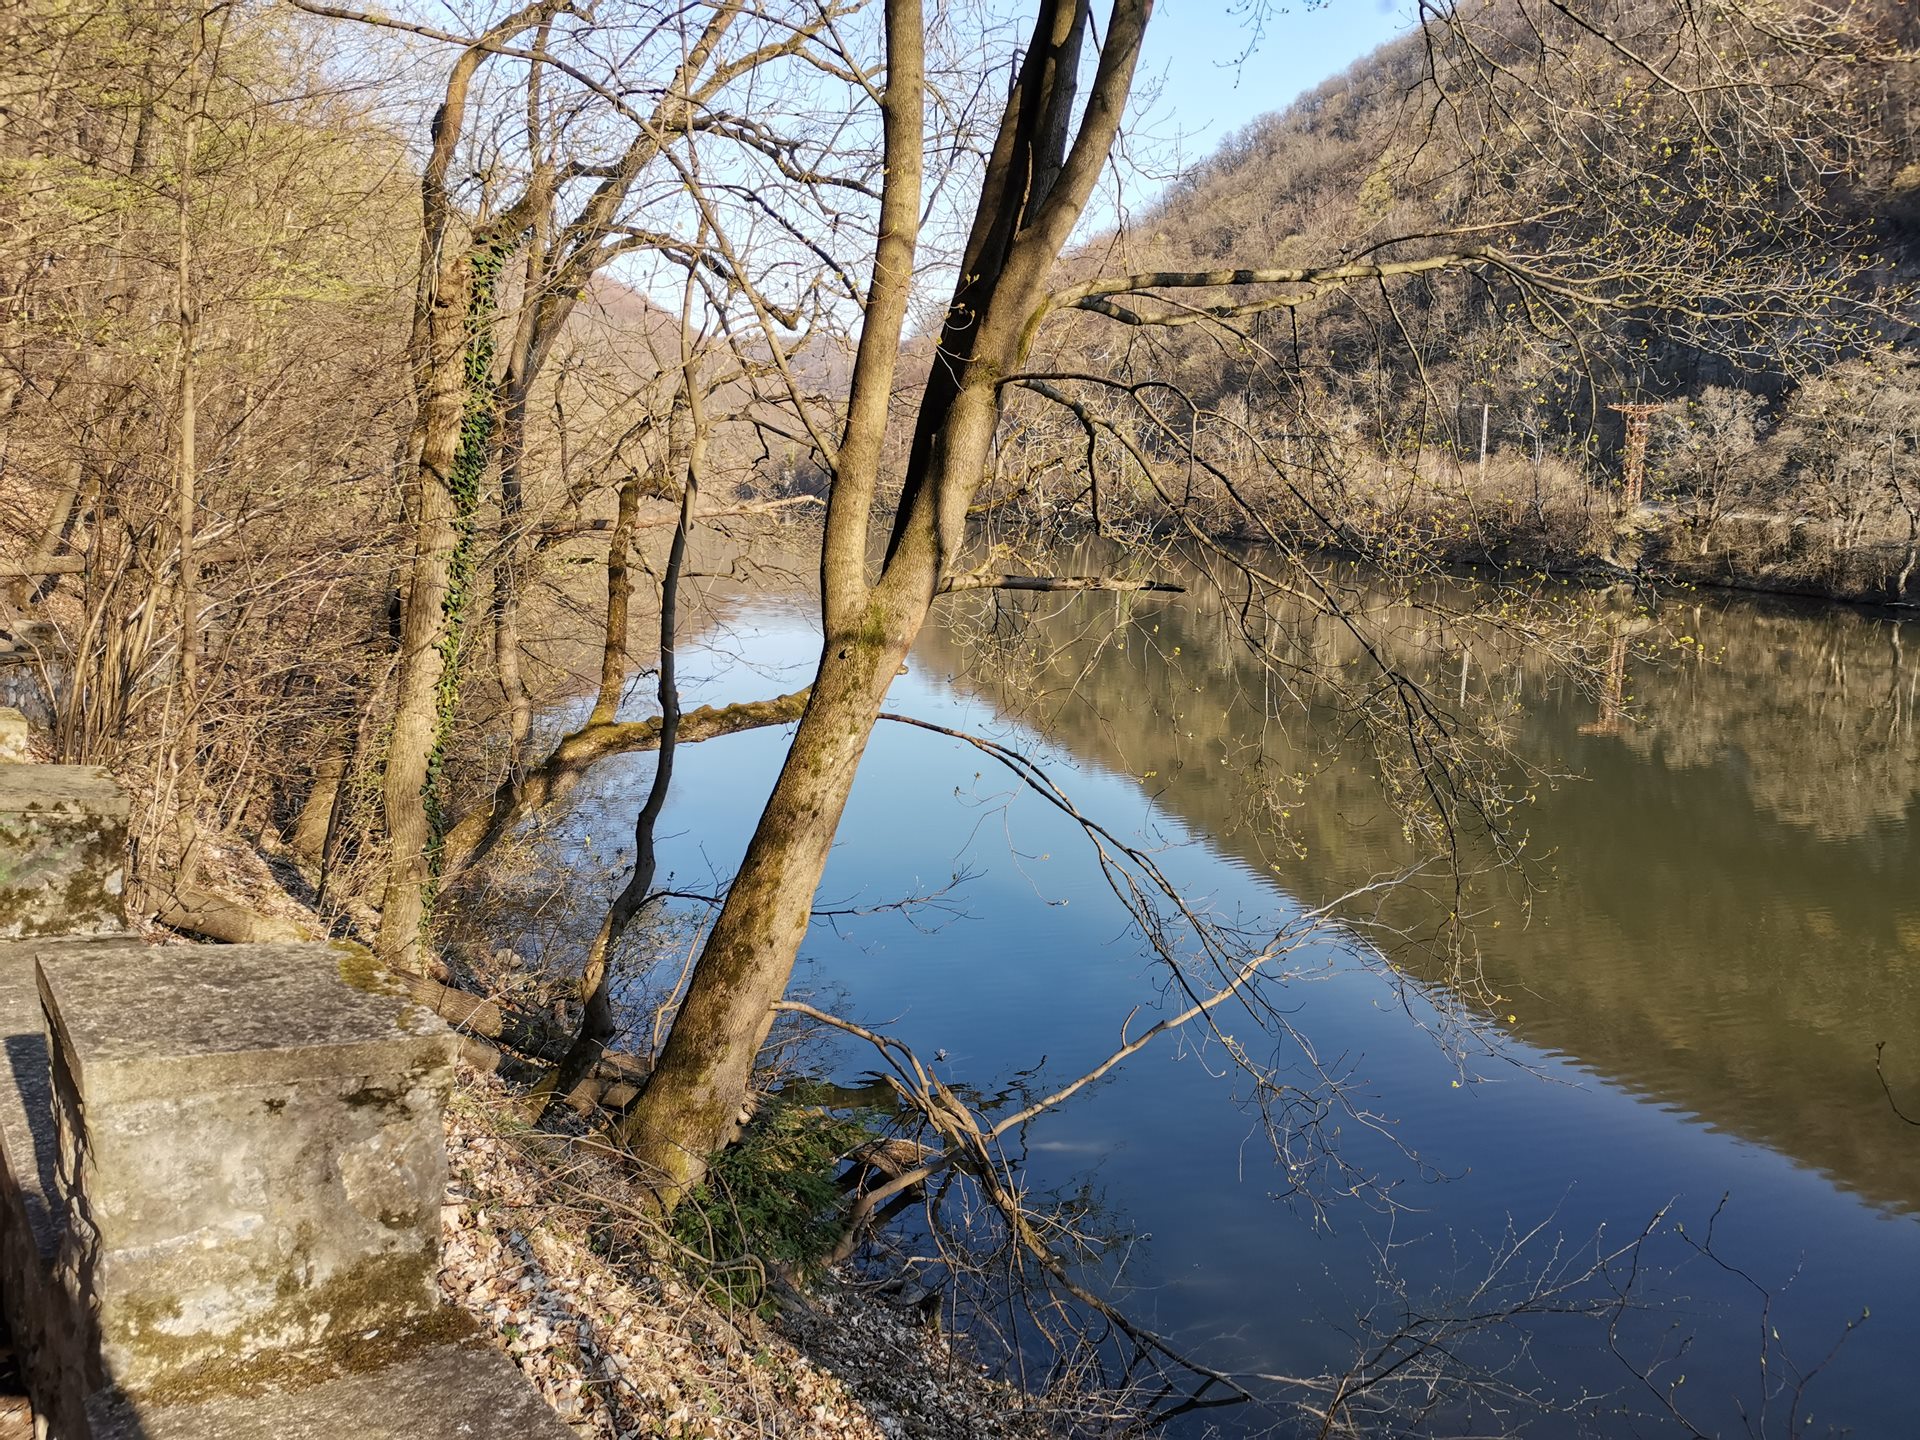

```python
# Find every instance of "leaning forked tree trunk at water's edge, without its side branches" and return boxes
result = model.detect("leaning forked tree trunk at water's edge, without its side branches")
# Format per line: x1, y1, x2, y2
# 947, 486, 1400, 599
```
622, 0, 1152, 1210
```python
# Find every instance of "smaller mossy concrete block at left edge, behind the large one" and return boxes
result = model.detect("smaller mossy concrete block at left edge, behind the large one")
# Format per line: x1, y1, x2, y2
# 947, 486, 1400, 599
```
0, 764, 127, 939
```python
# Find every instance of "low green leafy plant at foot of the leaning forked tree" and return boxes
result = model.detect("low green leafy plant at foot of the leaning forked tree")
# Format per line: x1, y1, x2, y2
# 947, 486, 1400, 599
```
674, 1102, 872, 1308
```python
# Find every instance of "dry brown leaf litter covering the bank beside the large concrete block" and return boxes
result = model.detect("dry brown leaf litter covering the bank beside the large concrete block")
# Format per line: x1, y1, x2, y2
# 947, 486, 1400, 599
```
440, 1075, 1056, 1440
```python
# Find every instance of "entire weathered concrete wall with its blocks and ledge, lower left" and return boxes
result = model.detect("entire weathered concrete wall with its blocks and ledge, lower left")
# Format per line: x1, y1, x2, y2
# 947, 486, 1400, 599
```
0, 756, 570, 1440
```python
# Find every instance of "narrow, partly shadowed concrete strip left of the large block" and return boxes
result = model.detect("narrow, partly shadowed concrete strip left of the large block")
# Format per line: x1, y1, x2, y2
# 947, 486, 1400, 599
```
0, 939, 142, 1436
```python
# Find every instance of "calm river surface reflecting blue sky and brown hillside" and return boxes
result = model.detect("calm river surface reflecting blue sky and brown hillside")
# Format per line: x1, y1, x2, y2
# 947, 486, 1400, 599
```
552, 568, 1920, 1436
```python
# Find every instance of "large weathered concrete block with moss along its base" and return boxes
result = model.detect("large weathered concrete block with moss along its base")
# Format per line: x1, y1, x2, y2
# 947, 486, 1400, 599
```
38, 943, 453, 1400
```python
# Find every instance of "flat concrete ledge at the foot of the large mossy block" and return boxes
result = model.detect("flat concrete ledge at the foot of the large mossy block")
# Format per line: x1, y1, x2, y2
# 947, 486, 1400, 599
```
88, 1342, 574, 1440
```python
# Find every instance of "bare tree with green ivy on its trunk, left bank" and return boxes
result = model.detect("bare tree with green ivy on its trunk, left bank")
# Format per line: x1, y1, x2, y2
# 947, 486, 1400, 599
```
288, 0, 875, 970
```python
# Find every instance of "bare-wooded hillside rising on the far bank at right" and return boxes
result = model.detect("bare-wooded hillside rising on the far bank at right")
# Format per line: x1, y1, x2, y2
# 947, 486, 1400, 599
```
1008, 0, 1920, 599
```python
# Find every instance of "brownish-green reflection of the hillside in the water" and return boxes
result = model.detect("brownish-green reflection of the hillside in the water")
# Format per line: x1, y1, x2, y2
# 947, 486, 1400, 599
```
920, 568, 1920, 1212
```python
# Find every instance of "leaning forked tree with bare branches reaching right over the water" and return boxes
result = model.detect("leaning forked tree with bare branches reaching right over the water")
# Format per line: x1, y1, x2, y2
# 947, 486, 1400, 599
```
622, 0, 1904, 1208
